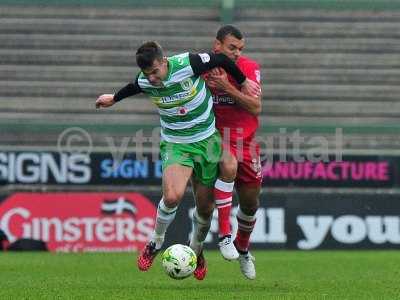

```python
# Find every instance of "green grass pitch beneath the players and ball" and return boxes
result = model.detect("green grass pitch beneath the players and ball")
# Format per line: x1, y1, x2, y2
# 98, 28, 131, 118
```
0, 251, 400, 300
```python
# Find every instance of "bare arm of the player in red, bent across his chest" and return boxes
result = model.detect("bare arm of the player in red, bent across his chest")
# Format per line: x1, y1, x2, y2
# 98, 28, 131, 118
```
207, 69, 262, 116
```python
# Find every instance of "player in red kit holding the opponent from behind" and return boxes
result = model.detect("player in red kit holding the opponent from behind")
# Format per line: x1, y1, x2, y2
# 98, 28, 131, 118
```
206, 25, 262, 279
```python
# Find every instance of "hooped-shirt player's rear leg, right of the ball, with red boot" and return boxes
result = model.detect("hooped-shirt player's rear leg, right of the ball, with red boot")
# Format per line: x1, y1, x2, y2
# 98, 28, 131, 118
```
190, 178, 214, 280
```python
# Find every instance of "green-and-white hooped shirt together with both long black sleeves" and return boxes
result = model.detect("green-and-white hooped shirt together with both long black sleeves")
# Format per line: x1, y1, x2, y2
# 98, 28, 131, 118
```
114, 53, 246, 144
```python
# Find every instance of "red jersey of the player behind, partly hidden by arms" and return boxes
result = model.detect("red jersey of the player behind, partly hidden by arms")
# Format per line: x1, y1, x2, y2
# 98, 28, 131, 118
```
205, 56, 261, 143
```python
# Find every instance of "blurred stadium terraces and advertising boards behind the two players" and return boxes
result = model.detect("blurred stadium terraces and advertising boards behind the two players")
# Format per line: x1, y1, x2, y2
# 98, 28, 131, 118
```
0, 0, 400, 251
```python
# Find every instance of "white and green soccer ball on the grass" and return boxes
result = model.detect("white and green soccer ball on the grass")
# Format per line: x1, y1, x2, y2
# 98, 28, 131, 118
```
161, 244, 197, 279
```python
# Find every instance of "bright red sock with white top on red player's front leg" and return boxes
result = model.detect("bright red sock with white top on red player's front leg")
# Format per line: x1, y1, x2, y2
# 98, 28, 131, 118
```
214, 179, 234, 237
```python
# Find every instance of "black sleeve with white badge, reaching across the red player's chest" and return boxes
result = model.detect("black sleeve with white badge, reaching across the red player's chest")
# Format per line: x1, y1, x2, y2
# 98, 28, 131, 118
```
189, 53, 246, 84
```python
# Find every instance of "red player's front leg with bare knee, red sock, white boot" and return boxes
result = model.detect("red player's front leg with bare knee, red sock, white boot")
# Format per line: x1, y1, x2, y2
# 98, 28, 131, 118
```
214, 147, 239, 260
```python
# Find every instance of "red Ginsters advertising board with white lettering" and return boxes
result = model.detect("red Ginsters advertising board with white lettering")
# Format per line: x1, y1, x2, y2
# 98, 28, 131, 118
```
0, 193, 156, 252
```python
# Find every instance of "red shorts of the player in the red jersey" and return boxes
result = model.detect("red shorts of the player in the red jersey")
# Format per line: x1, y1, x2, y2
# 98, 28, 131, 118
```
223, 141, 262, 187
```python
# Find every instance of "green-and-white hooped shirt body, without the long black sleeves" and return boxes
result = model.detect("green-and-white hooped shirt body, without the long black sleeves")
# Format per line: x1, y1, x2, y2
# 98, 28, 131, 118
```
138, 53, 216, 143
